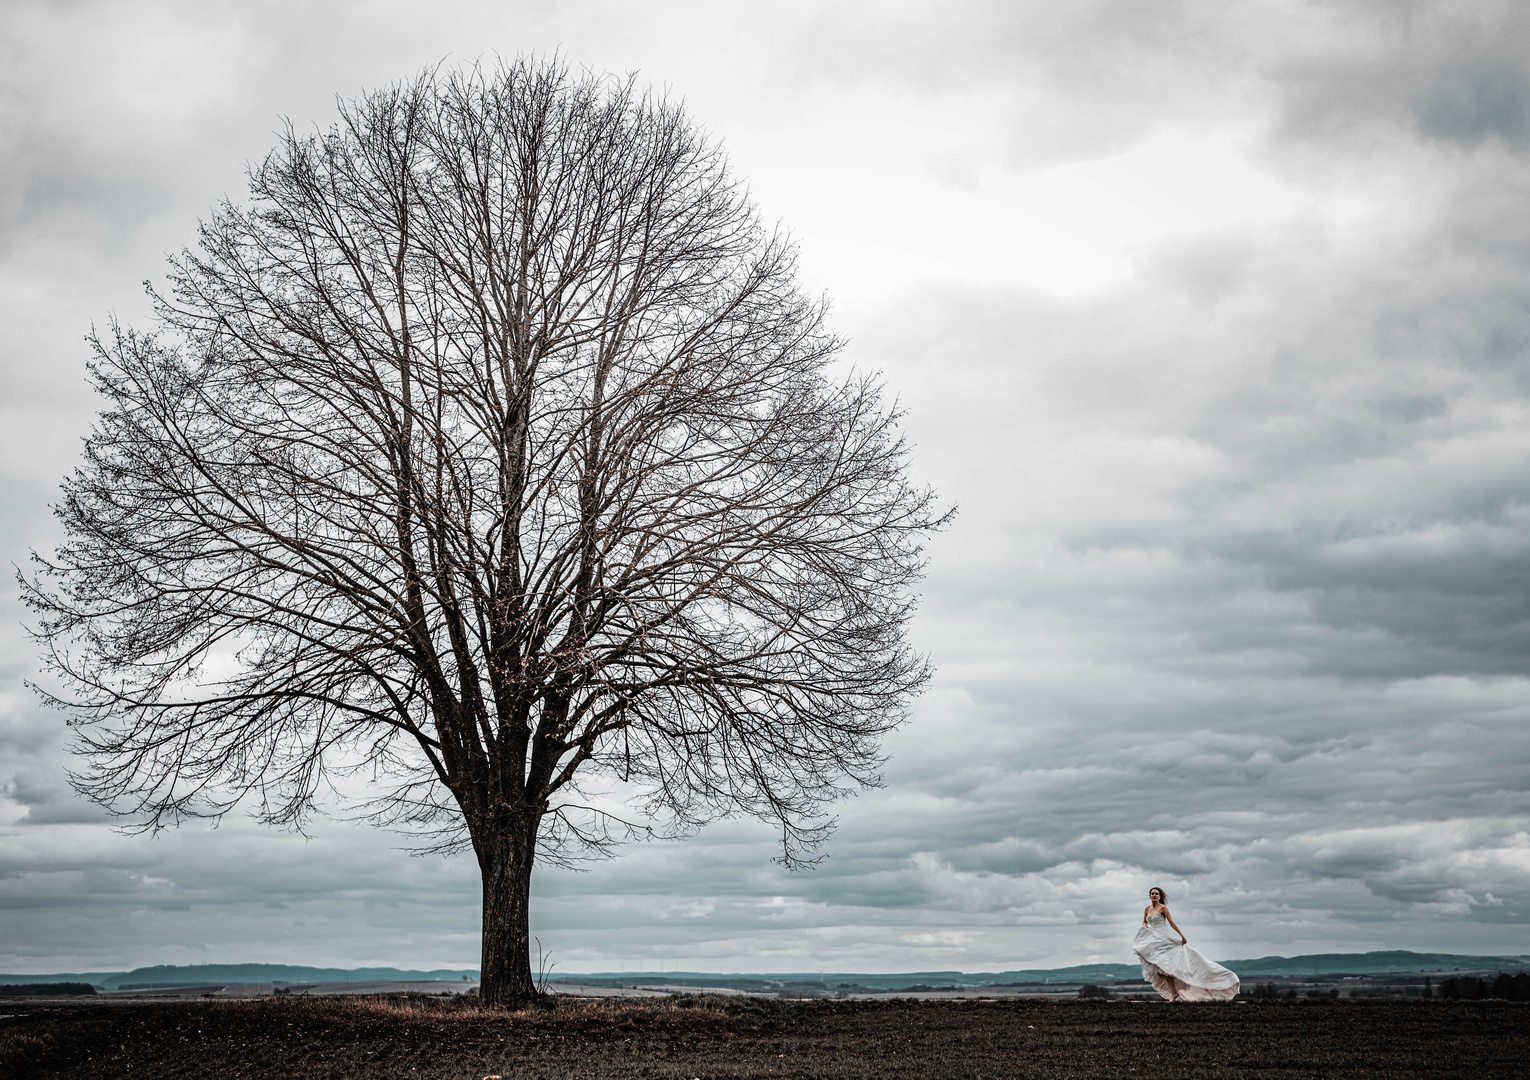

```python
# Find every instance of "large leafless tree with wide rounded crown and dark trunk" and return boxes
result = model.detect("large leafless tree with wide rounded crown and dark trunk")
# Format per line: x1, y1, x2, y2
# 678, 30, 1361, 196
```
23, 60, 941, 1000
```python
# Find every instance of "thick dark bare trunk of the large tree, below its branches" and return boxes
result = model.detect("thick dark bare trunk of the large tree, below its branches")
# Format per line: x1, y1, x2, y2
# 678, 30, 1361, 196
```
479, 831, 537, 1005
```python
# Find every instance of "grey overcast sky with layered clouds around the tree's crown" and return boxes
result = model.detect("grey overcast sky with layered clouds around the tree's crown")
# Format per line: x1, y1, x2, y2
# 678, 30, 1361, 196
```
0, 0, 1530, 971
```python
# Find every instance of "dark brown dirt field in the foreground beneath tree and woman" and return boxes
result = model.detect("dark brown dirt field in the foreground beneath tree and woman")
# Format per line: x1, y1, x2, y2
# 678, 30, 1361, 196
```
0, 996, 1530, 1080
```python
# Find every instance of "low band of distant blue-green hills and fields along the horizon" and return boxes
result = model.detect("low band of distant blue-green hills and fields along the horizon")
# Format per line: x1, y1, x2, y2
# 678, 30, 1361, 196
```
0, 950, 1530, 990
